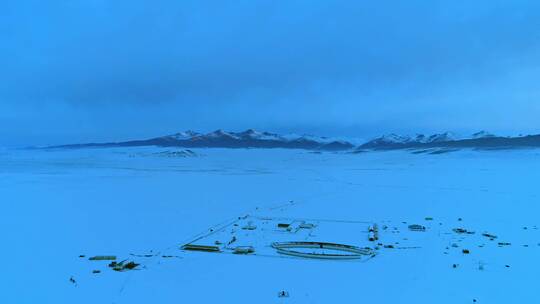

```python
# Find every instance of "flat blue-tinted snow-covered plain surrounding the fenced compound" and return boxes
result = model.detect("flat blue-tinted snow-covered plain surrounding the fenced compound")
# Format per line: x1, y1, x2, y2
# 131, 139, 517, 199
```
0, 148, 540, 304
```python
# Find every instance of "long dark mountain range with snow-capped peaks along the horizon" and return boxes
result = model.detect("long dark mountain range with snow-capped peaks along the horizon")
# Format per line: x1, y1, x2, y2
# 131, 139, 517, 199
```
49, 129, 540, 153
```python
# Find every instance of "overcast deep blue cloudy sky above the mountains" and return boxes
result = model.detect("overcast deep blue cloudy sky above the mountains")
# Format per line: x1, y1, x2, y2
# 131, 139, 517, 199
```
0, 0, 540, 145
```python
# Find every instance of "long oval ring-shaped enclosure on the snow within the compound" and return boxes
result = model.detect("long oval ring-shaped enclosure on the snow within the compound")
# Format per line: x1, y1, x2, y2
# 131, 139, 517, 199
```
272, 242, 373, 260
